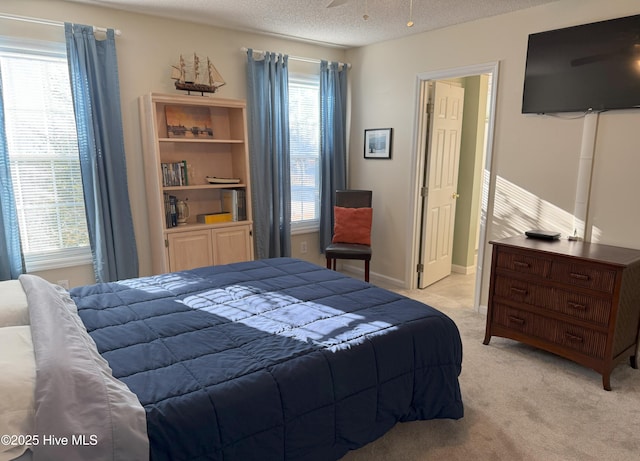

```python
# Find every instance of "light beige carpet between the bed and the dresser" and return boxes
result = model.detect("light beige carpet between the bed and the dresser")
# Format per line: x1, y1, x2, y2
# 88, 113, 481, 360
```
342, 276, 640, 461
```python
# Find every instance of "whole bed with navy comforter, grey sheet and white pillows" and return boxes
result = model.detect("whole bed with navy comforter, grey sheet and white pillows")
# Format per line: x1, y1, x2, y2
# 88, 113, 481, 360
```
0, 258, 464, 461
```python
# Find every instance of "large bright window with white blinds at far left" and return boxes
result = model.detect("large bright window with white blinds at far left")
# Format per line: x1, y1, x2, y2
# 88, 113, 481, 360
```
0, 42, 91, 271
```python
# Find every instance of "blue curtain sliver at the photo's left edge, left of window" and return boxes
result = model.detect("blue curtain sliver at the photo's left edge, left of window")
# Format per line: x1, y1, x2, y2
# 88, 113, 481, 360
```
0, 74, 24, 280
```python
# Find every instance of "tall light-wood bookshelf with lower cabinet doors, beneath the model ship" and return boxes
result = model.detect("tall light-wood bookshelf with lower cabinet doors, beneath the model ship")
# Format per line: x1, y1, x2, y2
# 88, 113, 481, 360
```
140, 93, 253, 273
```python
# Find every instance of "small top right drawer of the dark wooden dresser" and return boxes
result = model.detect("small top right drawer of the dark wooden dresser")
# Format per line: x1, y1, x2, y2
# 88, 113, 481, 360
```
551, 260, 617, 293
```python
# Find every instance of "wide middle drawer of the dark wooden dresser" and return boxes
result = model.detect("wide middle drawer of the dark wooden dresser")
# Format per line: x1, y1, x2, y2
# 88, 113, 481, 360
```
494, 275, 611, 327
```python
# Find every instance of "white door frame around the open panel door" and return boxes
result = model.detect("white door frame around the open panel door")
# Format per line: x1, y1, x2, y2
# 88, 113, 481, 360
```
405, 61, 500, 310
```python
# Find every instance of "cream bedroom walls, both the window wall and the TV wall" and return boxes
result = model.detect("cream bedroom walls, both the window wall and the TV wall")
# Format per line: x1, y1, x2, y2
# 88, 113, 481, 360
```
5, 0, 640, 294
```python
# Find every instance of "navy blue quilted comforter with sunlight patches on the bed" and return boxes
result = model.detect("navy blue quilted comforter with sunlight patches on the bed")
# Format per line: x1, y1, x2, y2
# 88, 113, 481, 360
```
71, 258, 463, 461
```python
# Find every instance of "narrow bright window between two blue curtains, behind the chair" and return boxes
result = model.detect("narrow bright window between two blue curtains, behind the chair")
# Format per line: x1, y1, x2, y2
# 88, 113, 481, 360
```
289, 74, 320, 232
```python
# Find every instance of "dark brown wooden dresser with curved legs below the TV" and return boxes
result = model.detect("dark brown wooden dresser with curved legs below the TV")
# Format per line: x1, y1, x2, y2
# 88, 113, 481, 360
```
484, 236, 640, 390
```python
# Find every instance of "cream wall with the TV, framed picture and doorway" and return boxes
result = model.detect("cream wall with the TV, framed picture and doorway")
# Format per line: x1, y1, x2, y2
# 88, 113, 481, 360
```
347, 0, 640, 299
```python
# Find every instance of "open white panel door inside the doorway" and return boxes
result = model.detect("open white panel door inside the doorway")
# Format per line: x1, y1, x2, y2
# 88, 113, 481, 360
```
419, 82, 464, 288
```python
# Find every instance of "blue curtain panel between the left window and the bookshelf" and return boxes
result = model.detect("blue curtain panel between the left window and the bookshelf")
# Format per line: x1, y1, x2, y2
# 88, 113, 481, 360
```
65, 23, 138, 282
